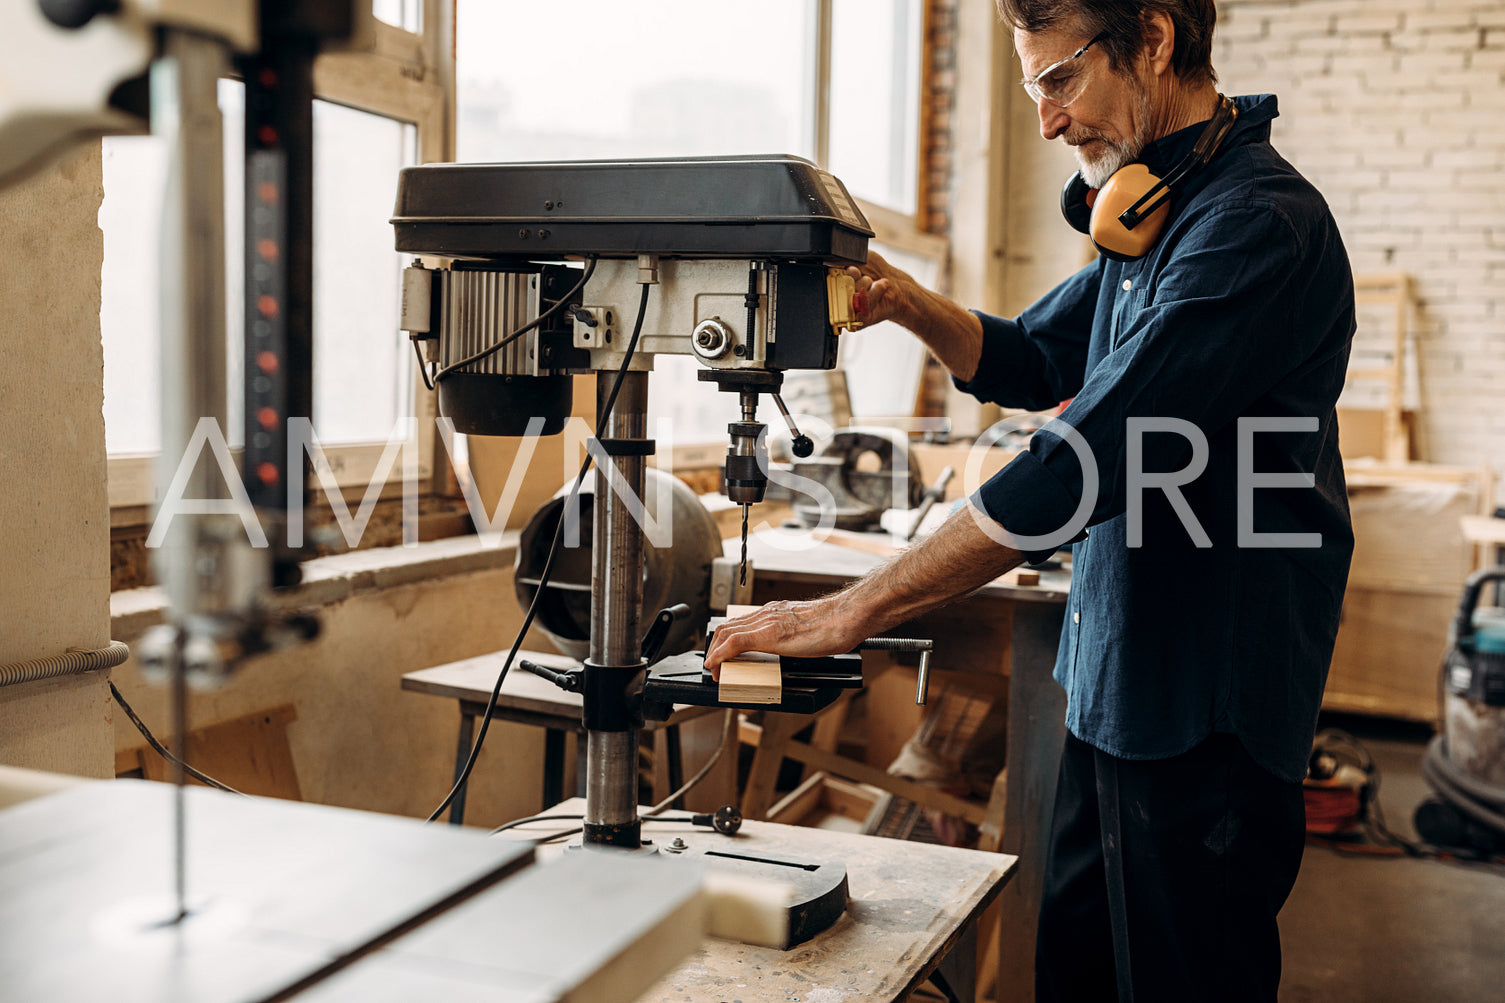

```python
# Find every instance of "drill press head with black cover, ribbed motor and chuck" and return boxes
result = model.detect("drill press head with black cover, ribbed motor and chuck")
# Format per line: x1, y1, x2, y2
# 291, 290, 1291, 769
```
393, 155, 873, 430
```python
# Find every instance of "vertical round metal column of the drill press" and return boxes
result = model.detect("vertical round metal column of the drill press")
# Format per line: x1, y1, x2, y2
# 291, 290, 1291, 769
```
584, 372, 649, 848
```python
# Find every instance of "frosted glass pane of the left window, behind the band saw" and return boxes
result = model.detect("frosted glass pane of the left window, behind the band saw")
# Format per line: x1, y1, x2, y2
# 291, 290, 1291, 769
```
99, 81, 415, 453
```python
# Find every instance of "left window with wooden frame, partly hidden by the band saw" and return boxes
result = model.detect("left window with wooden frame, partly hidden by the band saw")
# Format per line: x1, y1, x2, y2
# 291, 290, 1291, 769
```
99, 0, 450, 506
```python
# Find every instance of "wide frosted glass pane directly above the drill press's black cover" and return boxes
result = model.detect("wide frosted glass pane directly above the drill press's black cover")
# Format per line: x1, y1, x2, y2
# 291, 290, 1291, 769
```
456, 0, 814, 161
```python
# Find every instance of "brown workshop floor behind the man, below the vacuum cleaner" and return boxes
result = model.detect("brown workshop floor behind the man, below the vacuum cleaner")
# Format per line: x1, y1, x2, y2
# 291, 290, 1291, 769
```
1281, 718, 1505, 1003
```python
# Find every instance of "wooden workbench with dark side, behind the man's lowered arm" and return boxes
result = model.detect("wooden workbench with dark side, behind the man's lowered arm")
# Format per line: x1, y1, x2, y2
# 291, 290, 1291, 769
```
727, 530, 1070, 1000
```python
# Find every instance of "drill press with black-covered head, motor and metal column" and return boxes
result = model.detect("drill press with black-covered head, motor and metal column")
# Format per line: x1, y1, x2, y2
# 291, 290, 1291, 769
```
393, 157, 873, 848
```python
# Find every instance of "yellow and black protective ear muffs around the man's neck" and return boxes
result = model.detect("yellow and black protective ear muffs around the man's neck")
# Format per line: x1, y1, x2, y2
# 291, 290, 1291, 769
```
1061, 95, 1239, 261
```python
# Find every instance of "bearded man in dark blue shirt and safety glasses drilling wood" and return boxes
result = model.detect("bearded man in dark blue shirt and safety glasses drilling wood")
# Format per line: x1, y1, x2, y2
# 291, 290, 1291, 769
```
706, 0, 1353, 1003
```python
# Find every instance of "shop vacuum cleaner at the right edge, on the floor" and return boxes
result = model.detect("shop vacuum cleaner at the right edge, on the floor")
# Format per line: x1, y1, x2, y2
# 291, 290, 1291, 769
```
1415, 566, 1505, 855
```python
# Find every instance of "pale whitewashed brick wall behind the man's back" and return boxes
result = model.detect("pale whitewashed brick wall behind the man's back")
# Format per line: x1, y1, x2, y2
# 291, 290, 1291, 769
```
1213, 0, 1505, 471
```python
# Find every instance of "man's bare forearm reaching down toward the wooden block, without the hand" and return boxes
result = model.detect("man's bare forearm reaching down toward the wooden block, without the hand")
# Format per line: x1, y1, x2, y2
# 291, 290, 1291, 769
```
835, 506, 1025, 637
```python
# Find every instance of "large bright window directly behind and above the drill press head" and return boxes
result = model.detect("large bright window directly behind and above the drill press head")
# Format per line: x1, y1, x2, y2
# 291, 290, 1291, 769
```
456, 0, 945, 443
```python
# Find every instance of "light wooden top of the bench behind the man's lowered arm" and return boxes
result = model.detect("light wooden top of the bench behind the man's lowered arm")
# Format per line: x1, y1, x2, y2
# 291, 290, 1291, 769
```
722, 530, 1072, 604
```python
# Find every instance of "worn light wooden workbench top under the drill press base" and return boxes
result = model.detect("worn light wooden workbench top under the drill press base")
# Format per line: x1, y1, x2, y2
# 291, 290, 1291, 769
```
503, 798, 1019, 1003
